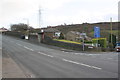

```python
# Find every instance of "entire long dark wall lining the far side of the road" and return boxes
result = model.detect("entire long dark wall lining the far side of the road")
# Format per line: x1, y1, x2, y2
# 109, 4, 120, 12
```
4, 32, 110, 52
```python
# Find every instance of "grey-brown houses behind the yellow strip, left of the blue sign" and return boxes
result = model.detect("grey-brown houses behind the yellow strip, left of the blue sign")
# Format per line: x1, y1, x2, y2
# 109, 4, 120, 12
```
65, 31, 91, 42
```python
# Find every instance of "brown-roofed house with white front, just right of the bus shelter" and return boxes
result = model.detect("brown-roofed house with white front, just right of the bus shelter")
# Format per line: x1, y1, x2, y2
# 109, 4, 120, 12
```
42, 27, 61, 38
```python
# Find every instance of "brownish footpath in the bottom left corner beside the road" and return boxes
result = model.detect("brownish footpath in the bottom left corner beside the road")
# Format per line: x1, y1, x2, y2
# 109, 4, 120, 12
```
0, 49, 26, 78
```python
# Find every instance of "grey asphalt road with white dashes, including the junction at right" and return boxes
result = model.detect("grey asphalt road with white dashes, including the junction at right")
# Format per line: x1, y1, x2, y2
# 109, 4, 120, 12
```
2, 36, 119, 78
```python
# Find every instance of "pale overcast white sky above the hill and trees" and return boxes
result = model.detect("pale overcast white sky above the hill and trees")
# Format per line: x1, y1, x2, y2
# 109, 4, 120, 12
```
0, 0, 119, 28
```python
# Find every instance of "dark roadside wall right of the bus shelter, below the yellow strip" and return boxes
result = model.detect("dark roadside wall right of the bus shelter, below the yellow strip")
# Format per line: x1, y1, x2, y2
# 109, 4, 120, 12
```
43, 36, 101, 51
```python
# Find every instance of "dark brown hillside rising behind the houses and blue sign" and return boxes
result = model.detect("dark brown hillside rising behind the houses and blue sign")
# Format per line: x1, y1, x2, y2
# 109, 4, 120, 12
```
41, 22, 120, 38
